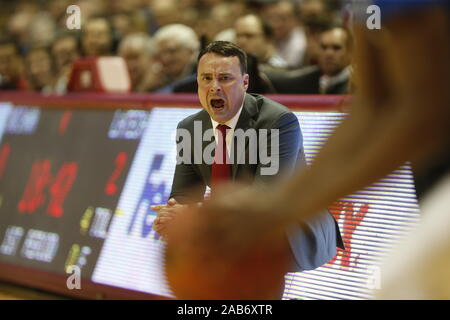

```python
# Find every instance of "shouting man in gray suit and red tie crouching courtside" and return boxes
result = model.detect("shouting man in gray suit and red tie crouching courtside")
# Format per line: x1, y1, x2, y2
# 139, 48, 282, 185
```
152, 41, 342, 280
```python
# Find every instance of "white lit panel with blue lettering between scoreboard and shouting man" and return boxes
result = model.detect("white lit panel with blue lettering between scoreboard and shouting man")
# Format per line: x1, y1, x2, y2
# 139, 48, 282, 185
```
92, 108, 198, 296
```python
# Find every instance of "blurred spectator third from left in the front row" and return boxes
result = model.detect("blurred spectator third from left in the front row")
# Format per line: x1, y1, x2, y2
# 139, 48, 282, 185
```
51, 32, 81, 94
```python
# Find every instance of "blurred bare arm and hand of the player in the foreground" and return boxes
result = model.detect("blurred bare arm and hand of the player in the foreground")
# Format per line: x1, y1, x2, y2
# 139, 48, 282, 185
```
188, 6, 450, 257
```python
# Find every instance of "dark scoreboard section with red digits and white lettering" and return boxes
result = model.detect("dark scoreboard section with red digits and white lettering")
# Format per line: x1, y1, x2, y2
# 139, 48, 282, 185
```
0, 106, 143, 277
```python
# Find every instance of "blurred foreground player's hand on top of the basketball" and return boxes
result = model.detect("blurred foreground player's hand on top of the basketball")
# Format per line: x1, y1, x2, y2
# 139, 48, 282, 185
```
169, 183, 287, 259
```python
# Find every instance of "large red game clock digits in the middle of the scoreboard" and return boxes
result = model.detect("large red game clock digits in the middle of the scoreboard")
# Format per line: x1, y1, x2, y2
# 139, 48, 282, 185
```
18, 160, 78, 218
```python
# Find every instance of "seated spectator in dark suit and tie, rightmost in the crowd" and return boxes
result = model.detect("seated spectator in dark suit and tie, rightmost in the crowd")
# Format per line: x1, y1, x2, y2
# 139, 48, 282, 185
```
269, 27, 352, 94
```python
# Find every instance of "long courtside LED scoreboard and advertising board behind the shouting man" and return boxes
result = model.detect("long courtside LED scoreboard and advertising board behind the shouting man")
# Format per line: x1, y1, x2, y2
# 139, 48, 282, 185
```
0, 96, 418, 299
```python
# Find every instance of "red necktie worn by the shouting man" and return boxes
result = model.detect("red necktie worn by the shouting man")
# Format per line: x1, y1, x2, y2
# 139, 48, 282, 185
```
211, 124, 231, 192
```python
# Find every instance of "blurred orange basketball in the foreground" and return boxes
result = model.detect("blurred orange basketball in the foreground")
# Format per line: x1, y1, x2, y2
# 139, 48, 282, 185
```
164, 186, 291, 299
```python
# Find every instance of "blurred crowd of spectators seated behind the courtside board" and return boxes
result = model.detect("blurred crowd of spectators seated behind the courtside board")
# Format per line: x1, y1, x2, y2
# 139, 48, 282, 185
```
0, 0, 353, 94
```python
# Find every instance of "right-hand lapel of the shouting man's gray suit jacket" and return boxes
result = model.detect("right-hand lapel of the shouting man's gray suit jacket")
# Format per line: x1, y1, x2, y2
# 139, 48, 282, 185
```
231, 94, 258, 180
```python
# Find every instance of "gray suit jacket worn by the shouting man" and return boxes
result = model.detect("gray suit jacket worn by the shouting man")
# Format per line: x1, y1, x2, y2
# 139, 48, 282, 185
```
170, 94, 342, 271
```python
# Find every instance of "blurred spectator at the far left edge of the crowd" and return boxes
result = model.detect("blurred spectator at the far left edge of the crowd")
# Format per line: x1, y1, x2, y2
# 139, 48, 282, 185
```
0, 39, 28, 90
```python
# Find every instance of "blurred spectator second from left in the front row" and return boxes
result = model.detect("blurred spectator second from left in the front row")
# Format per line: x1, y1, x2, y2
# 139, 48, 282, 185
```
25, 47, 55, 93
